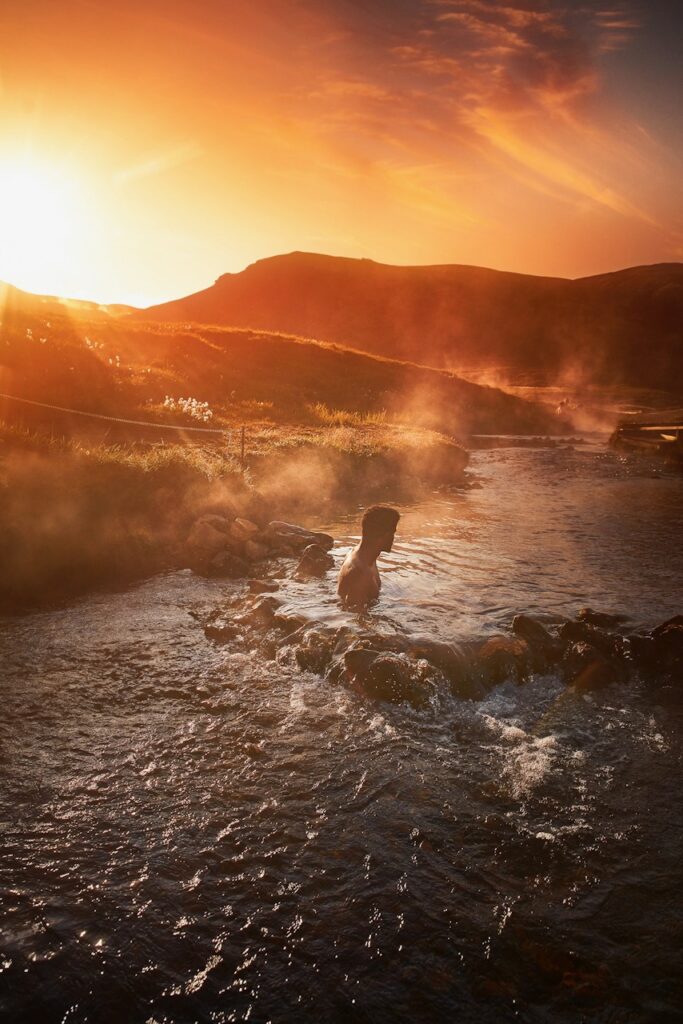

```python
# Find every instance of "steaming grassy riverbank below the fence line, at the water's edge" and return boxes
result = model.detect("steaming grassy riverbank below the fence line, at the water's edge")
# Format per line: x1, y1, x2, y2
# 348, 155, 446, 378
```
0, 418, 467, 612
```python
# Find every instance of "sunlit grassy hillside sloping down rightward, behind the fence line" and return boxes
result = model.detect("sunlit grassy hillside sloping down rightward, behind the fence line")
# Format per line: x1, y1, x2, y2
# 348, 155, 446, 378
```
0, 292, 561, 437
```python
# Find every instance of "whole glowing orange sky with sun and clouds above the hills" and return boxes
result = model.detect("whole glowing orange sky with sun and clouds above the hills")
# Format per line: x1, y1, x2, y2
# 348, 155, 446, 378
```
0, 0, 683, 305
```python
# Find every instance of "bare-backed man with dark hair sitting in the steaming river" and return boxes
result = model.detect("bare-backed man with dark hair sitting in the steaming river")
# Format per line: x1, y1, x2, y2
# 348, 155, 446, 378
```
337, 505, 400, 607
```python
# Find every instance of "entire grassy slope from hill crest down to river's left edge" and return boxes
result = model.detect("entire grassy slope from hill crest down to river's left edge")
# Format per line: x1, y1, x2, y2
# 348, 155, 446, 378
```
0, 303, 563, 610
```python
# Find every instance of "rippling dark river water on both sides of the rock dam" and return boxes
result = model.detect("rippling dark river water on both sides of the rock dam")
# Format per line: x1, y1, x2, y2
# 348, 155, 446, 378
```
0, 445, 683, 1024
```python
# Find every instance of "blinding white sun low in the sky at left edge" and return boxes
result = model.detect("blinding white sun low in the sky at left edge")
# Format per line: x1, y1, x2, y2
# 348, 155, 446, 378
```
0, 161, 86, 294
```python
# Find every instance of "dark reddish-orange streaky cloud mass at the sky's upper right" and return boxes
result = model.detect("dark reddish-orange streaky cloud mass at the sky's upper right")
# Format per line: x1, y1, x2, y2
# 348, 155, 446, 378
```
272, 0, 655, 225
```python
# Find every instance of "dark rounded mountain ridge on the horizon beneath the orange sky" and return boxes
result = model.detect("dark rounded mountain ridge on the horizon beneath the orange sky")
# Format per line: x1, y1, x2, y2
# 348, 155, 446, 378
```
140, 253, 683, 387
